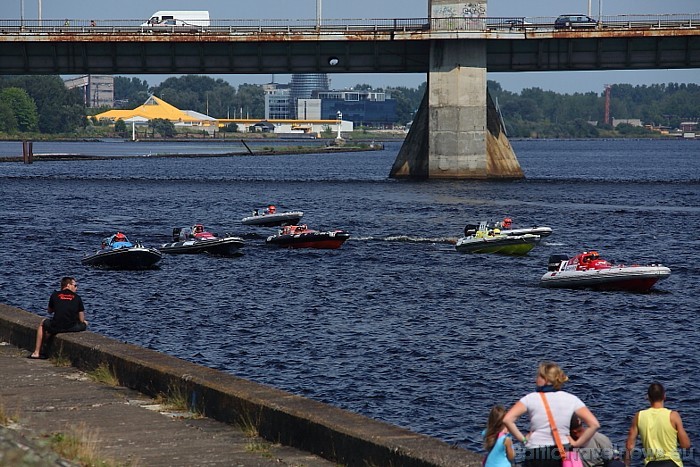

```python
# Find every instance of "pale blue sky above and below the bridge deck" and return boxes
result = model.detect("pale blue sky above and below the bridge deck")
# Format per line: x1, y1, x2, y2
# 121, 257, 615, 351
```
6, 0, 700, 94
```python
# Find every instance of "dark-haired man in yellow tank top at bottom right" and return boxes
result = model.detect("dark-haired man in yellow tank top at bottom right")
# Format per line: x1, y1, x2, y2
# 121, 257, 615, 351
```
625, 383, 690, 467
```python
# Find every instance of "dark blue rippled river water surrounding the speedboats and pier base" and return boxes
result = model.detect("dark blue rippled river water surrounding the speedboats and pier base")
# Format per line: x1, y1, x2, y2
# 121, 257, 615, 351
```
0, 140, 700, 465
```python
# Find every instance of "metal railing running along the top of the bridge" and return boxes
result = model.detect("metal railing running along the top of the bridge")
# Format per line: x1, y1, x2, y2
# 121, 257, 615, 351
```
0, 13, 700, 35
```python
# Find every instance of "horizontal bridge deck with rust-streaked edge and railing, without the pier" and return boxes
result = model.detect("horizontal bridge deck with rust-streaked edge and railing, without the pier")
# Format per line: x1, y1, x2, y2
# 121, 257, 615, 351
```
0, 14, 700, 75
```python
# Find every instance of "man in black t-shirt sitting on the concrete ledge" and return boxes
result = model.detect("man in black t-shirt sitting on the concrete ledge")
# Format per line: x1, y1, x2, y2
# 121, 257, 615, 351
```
29, 276, 88, 358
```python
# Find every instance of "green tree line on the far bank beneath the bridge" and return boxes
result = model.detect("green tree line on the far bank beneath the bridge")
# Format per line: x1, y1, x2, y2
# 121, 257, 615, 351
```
0, 75, 700, 138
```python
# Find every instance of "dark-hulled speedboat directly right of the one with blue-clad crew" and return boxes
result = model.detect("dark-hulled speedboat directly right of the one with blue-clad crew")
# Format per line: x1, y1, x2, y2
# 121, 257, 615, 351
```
159, 224, 243, 256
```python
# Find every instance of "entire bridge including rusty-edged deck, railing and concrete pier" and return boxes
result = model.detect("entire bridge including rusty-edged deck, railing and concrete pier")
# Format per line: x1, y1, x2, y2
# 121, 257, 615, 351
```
0, 0, 700, 179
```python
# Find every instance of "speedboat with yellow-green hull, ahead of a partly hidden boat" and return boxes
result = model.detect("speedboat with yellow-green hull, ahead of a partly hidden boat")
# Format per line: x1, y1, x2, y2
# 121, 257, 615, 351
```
455, 221, 540, 255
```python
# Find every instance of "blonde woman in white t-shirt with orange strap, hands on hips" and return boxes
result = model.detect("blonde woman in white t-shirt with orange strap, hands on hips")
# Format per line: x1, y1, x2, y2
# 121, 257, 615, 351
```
503, 362, 600, 467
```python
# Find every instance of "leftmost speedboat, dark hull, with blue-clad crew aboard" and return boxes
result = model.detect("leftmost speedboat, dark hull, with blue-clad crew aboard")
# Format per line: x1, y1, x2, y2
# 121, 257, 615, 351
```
80, 232, 163, 269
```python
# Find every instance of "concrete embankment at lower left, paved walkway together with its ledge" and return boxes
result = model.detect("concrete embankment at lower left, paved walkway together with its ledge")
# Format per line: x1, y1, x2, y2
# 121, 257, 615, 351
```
0, 304, 481, 467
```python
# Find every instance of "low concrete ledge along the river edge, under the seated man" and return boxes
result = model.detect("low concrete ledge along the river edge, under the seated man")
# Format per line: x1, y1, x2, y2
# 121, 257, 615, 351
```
0, 304, 481, 467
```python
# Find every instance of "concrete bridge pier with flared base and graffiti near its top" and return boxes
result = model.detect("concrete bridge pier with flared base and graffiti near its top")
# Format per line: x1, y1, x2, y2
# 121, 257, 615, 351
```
390, 0, 524, 180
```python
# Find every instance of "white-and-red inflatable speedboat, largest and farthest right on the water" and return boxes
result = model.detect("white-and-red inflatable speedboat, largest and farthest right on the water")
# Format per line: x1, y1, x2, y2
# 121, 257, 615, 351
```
540, 251, 671, 292
